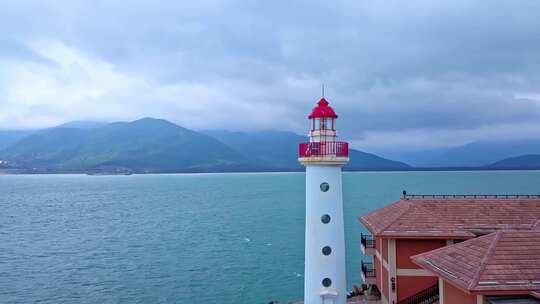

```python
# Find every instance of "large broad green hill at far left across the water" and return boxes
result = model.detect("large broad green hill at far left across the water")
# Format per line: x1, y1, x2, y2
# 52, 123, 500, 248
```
0, 118, 250, 172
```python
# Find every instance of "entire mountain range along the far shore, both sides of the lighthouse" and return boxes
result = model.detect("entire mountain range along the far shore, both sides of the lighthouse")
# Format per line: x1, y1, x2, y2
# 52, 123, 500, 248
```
0, 118, 540, 172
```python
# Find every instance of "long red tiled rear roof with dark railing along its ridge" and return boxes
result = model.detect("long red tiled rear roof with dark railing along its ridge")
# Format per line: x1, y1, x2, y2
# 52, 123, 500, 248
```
360, 198, 540, 239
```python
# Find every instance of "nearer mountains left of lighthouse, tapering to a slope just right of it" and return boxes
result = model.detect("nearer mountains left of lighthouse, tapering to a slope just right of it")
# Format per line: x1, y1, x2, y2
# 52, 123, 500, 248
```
0, 118, 409, 173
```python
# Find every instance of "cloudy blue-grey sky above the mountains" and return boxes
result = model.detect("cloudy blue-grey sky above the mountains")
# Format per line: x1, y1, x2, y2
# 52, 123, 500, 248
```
0, 0, 540, 151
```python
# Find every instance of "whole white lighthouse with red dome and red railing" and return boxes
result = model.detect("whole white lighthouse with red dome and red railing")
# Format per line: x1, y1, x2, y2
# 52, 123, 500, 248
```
299, 97, 349, 304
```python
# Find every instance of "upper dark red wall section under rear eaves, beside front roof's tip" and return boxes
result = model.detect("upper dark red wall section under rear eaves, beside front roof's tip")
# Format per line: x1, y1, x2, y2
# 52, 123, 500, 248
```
396, 239, 446, 269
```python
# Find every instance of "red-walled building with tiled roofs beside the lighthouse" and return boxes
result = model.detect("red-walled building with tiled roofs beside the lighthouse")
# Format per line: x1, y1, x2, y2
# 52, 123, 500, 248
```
360, 192, 540, 304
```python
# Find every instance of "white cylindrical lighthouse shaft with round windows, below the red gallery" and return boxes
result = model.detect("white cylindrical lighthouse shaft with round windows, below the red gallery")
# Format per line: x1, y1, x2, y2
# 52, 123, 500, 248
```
304, 163, 347, 304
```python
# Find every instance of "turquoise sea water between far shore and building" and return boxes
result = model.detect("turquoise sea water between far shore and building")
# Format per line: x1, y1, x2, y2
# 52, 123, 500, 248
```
0, 171, 540, 303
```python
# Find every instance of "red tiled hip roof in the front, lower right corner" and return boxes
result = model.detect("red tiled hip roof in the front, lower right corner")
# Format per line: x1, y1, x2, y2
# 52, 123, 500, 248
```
411, 230, 540, 292
